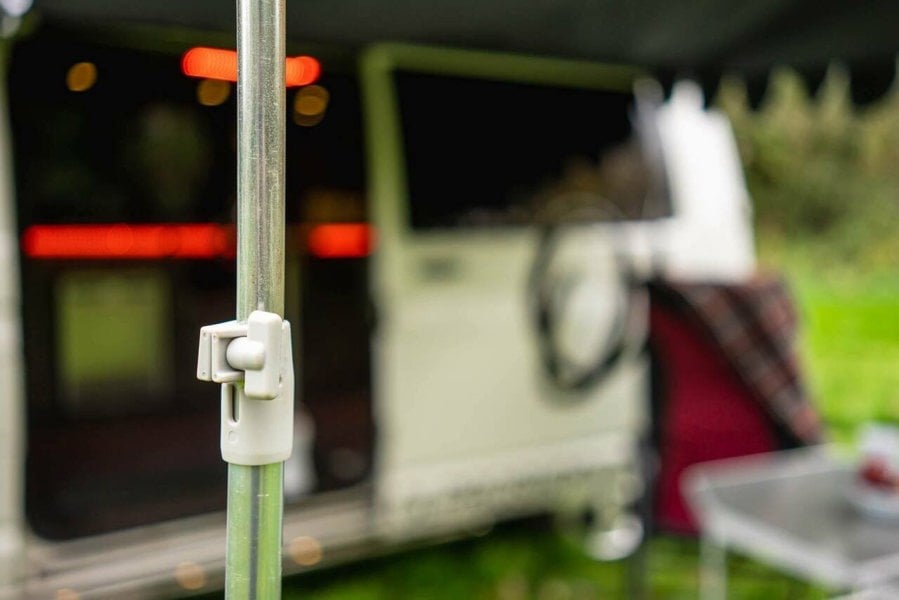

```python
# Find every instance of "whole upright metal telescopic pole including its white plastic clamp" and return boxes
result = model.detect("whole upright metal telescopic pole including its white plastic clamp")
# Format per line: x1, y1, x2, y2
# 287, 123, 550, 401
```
197, 0, 293, 600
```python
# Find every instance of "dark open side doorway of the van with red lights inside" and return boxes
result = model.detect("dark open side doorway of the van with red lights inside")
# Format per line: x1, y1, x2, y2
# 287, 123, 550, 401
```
9, 23, 373, 539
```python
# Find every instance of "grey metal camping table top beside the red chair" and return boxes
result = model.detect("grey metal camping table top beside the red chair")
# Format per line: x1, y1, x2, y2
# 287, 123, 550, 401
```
683, 447, 899, 589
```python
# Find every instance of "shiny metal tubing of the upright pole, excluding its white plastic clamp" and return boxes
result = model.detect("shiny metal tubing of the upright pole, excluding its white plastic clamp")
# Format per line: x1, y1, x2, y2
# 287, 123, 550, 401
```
225, 0, 285, 600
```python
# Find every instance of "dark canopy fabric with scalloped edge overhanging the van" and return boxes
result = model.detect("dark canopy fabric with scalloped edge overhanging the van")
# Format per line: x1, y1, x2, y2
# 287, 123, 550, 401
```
36, 0, 899, 101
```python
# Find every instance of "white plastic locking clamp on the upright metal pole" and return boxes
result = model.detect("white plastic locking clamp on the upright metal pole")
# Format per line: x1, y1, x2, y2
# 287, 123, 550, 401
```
197, 310, 294, 465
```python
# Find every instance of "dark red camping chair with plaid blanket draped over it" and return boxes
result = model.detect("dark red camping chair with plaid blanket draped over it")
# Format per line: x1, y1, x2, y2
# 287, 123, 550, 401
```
647, 276, 822, 534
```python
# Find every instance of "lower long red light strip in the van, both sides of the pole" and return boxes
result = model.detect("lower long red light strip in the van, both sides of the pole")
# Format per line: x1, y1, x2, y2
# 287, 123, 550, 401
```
22, 223, 375, 260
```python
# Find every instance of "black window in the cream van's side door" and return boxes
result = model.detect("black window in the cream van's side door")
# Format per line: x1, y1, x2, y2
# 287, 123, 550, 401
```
395, 71, 645, 229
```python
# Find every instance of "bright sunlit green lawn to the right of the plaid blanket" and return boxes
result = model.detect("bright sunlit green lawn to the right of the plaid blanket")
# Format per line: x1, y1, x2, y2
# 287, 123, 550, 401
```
766, 244, 899, 444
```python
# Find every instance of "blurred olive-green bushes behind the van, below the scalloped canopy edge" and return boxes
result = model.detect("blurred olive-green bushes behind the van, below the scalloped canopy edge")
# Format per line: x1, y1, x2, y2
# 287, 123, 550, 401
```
718, 68, 899, 268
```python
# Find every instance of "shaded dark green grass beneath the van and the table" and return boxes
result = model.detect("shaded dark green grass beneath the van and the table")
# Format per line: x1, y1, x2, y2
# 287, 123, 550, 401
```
284, 524, 825, 600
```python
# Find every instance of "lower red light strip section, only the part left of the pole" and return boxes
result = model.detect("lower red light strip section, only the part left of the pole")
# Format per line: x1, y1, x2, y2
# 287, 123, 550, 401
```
22, 223, 235, 260
